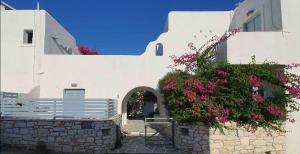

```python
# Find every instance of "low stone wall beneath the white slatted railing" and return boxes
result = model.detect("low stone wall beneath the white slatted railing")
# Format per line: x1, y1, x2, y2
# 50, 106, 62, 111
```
1, 116, 121, 154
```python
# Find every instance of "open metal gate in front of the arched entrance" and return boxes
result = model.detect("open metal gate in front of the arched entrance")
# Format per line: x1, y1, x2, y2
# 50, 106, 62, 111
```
145, 118, 175, 147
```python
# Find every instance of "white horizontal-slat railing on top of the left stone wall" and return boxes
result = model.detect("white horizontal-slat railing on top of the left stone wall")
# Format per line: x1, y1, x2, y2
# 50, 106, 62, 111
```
0, 98, 117, 119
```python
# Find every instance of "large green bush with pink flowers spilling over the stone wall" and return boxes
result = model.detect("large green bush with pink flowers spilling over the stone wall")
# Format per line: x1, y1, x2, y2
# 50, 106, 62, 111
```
159, 30, 300, 131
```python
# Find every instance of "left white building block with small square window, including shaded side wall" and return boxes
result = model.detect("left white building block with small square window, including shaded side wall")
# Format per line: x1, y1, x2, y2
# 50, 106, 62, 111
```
1, 10, 78, 97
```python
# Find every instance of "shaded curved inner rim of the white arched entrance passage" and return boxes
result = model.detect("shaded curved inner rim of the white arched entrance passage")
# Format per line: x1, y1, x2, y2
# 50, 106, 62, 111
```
122, 87, 167, 124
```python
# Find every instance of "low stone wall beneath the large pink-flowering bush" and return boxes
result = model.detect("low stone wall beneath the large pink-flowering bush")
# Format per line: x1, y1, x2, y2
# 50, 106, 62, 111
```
175, 123, 286, 154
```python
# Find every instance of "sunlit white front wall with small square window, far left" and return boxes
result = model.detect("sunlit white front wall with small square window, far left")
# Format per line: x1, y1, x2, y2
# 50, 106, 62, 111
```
1, 10, 42, 97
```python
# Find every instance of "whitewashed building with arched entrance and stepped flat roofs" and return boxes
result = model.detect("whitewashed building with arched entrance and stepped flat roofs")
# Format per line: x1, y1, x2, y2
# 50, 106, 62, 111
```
1, 0, 300, 154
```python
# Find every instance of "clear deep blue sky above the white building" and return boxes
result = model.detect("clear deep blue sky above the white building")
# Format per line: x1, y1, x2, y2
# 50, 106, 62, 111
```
3, 0, 241, 54
